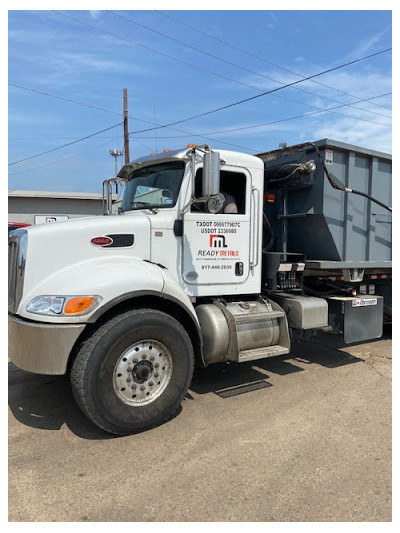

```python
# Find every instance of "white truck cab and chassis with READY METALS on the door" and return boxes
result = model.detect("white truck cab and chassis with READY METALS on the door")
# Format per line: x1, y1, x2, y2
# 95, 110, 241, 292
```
8, 143, 391, 435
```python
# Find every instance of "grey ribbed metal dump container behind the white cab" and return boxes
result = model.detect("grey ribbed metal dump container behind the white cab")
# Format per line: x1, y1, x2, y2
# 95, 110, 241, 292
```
258, 139, 392, 268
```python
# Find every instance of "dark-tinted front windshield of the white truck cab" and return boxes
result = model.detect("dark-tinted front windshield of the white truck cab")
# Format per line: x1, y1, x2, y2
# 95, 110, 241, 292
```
121, 161, 185, 211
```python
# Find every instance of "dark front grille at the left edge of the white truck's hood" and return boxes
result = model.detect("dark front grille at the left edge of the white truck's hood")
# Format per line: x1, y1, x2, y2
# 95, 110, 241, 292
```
8, 229, 28, 313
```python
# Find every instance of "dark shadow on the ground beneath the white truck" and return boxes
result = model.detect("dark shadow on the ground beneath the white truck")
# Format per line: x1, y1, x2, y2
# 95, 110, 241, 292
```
8, 332, 391, 440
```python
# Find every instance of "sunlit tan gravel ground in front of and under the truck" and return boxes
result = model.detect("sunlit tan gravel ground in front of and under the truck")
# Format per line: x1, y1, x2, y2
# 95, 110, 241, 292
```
9, 328, 392, 522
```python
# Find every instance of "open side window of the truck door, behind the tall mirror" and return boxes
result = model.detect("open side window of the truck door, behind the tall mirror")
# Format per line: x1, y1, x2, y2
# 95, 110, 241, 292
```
191, 168, 246, 215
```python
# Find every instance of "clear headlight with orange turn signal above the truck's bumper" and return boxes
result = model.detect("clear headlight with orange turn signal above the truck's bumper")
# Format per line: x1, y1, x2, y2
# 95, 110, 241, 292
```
26, 296, 101, 316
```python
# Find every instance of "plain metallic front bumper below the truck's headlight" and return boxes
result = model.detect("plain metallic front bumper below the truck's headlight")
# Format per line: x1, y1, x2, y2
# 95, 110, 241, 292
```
8, 315, 85, 375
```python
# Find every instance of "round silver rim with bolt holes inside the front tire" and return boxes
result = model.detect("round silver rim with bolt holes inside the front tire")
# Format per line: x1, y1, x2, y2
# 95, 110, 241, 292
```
113, 339, 173, 407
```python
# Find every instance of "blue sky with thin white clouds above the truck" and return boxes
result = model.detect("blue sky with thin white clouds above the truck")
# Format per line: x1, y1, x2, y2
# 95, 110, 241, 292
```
8, 8, 392, 192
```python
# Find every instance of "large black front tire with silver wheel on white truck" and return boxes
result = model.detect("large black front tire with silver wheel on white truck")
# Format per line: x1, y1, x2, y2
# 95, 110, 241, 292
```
71, 309, 194, 435
